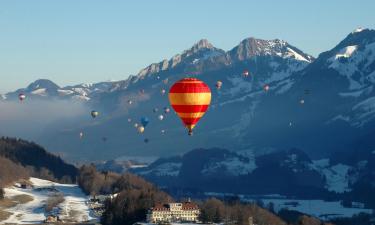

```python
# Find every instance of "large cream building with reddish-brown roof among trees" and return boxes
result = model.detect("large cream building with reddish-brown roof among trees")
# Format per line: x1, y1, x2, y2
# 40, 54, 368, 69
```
147, 202, 200, 223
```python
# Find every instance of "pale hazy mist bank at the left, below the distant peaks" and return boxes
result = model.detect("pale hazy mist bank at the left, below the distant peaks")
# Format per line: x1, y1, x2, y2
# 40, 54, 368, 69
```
0, 100, 88, 139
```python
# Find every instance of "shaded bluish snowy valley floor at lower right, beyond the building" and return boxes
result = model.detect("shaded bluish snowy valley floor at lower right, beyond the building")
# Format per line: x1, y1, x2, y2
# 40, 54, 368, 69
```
206, 192, 372, 220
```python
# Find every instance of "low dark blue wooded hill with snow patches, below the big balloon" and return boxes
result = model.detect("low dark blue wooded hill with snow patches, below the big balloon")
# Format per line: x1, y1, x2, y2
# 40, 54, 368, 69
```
132, 148, 375, 204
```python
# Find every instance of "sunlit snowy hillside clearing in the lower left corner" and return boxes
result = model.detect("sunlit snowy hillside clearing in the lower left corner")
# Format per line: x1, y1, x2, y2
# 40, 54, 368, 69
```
0, 178, 95, 224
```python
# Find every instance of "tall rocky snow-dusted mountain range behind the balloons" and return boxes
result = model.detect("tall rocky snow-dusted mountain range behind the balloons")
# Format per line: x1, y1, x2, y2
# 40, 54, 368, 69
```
2, 29, 375, 160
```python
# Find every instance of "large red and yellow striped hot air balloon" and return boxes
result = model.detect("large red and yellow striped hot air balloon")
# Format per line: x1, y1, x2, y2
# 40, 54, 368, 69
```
169, 78, 211, 135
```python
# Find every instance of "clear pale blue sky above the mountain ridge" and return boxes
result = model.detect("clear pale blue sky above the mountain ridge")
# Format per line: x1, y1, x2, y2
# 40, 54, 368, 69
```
0, 0, 375, 93
